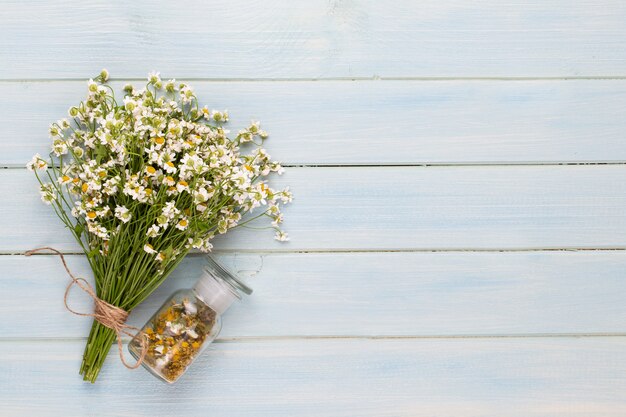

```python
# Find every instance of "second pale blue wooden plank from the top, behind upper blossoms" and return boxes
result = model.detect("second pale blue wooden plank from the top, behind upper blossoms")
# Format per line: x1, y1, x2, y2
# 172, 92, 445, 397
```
0, 80, 626, 167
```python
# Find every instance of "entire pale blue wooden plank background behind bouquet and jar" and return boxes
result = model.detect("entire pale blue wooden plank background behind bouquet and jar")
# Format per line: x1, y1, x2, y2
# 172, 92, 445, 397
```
0, 0, 626, 417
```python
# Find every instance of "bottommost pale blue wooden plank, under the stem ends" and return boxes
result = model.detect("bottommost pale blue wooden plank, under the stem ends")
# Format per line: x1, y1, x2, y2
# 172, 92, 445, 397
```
0, 338, 626, 417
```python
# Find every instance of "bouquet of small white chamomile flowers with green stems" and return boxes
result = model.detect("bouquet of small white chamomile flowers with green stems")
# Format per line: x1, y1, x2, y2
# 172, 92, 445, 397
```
27, 70, 292, 382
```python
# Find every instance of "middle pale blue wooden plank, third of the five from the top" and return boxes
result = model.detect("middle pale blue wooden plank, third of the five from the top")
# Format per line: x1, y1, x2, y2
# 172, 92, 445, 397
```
0, 165, 626, 252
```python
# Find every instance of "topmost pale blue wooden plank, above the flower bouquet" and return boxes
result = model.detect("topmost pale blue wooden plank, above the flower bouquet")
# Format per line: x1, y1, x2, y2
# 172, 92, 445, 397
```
0, 0, 626, 79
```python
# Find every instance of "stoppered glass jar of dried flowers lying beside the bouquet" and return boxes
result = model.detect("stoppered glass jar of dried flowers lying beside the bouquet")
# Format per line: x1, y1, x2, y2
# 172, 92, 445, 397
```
128, 258, 252, 383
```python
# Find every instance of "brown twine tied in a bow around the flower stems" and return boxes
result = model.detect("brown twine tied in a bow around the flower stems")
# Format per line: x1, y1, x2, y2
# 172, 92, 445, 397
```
24, 246, 148, 369
